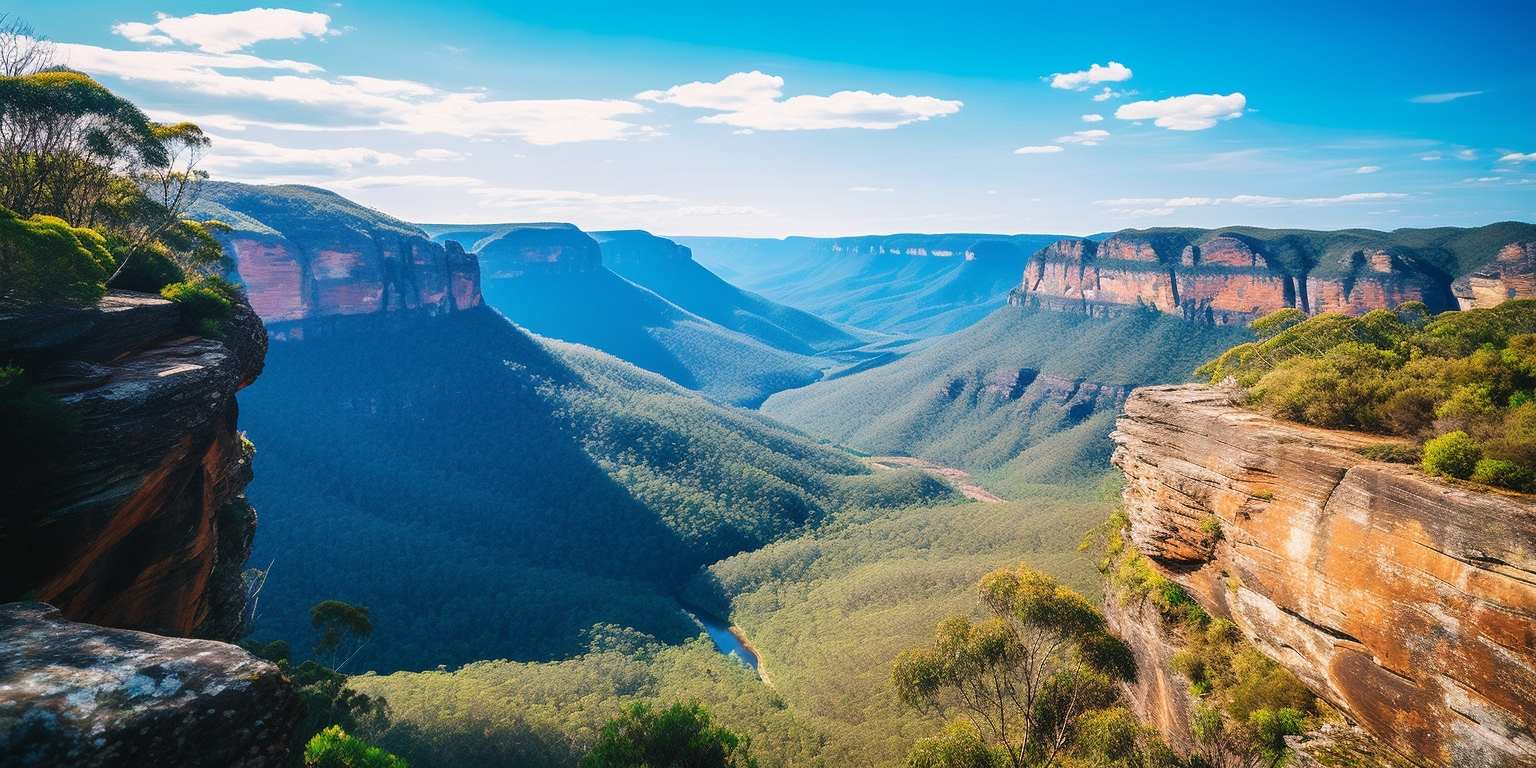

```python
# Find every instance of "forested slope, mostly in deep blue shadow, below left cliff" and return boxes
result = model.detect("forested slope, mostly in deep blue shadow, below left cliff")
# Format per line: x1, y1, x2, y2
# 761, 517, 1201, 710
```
241, 302, 949, 671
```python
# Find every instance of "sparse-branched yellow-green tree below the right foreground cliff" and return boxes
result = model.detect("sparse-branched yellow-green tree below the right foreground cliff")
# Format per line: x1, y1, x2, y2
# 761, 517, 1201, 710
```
891, 565, 1135, 766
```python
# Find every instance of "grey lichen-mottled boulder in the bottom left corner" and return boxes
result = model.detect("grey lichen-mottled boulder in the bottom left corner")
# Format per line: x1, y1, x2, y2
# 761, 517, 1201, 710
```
0, 602, 300, 768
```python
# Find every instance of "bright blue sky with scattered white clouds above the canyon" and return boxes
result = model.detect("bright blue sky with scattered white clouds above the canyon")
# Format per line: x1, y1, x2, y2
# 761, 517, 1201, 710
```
12, 0, 1536, 235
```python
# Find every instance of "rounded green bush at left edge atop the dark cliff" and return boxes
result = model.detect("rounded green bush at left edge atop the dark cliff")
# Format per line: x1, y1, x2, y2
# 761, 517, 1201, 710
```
0, 207, 115, 307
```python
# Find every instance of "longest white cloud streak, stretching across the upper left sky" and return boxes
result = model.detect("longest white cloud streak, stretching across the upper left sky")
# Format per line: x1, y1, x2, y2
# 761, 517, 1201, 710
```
58, 43, 654, 144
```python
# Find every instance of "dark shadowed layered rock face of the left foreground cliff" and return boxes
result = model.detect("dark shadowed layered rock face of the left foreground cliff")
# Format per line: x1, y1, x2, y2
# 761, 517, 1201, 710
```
0, 292, 267, 639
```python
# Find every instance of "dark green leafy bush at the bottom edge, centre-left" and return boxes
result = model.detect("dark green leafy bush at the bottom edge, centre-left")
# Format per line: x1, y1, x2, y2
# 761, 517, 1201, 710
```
582, 702, 757, 768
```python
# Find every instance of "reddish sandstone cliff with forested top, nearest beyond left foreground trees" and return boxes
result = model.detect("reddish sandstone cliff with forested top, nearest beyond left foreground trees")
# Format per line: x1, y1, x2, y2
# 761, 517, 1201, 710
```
197, 181, 481, 338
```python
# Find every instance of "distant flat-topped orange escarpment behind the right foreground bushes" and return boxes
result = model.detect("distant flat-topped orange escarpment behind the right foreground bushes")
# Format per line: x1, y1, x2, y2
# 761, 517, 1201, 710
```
1009, 224, 1536, 324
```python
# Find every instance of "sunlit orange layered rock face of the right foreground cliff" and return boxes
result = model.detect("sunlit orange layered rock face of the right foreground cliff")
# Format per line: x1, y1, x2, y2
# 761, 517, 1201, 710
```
1114, 386, 1536, 766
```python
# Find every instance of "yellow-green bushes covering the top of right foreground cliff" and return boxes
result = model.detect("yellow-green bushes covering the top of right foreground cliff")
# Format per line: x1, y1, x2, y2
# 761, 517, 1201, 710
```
1200, 300, 1536, 490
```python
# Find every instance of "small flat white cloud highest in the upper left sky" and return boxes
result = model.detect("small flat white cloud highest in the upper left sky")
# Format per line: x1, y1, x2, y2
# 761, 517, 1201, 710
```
112, 8, 335, 54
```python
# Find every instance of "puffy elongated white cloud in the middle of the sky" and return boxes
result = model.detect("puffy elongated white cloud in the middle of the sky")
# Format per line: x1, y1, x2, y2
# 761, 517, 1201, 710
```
634, 71, 965, 131
